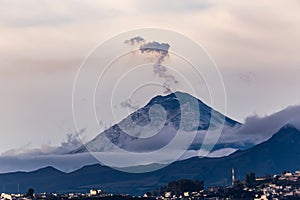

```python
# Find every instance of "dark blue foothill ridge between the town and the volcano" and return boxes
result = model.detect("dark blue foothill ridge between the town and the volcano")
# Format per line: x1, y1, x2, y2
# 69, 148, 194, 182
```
0, 125, 300, 195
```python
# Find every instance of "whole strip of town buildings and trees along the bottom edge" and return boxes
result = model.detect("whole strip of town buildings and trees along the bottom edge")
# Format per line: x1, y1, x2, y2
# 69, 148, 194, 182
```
1, 169, 300, 200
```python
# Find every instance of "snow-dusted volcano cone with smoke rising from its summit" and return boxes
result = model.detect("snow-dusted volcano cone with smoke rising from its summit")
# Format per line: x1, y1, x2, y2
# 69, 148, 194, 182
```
71, 92, 239, 153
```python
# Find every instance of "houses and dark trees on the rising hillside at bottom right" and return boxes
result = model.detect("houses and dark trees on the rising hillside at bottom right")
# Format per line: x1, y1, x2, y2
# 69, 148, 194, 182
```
151, 171, 300, 200
